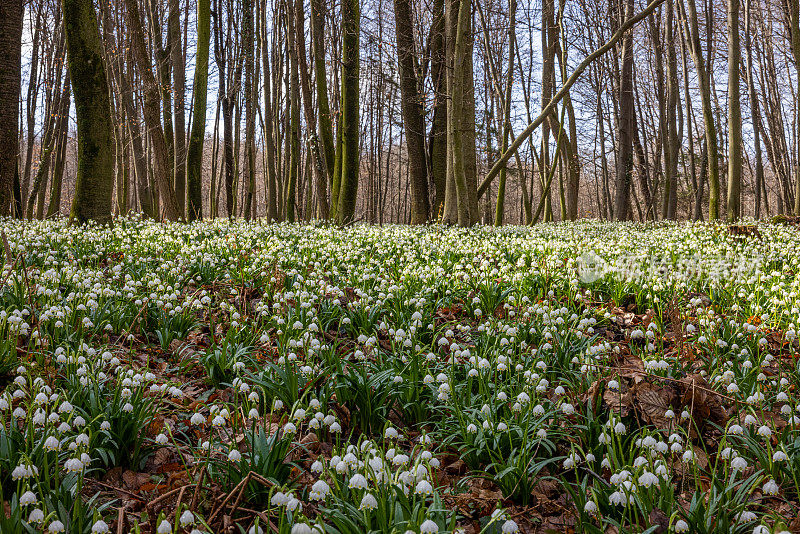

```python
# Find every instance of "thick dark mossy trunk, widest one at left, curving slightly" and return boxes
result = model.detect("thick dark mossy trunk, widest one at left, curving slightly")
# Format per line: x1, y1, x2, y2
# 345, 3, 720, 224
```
63, 0, 114, 223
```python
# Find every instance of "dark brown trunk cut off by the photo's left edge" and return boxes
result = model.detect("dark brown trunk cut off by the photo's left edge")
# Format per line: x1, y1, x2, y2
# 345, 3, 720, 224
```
0, 0, 24, 215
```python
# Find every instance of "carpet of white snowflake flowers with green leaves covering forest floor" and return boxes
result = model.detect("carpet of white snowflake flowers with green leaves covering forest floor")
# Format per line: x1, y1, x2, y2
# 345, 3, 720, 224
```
0, 218, 800, 534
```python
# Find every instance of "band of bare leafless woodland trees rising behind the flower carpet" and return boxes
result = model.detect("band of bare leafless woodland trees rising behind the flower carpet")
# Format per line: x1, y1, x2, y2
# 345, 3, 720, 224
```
0, 0, 800, 226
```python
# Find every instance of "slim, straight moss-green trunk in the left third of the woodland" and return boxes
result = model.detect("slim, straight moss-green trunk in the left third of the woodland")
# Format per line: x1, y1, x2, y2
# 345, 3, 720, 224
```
186, 0, 213, 221
